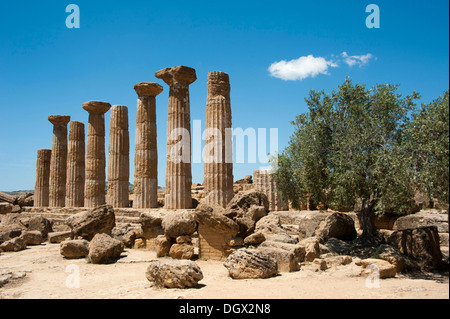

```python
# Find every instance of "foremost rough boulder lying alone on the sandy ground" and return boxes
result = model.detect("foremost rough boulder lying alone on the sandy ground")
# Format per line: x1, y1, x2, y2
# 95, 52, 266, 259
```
145, 259, 203, 289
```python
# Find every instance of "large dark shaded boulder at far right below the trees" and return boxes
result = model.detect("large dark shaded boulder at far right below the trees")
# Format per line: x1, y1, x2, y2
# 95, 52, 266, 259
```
388, 226, 442, 271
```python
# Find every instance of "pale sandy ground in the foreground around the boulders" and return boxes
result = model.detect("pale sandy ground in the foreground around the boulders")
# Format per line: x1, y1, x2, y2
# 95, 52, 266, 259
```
0, 244, 449, 299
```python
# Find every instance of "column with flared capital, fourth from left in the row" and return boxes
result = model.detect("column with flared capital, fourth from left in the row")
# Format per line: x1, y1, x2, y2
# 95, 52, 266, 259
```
83, 101, 111, 207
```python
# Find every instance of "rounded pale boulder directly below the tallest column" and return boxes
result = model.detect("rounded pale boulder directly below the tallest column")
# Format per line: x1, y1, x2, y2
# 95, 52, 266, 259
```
161, 210, 197, 238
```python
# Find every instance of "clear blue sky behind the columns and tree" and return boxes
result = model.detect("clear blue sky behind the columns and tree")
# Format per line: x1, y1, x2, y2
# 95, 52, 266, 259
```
0, 0, 449, 191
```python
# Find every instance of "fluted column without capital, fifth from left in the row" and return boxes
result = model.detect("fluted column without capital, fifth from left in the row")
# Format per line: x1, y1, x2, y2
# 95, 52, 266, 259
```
106, 105, 130, 208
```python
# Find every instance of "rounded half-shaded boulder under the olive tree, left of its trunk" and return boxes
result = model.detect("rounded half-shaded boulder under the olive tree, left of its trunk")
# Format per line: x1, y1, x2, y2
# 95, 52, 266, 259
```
316, 213, 357, 242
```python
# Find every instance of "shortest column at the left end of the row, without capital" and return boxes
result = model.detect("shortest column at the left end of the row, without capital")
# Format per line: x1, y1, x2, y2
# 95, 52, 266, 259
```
34, 149, 52, 207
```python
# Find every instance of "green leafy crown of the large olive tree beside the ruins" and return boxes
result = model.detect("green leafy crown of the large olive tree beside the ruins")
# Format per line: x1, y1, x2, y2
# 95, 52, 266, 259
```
275, 78, 436, 236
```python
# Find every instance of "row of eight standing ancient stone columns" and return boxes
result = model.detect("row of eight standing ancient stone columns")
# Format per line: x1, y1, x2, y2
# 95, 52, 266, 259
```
34, 66, 233, 209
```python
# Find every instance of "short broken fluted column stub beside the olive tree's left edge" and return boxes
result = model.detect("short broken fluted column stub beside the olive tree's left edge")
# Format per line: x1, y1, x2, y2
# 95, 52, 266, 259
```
253, 169, 289, 211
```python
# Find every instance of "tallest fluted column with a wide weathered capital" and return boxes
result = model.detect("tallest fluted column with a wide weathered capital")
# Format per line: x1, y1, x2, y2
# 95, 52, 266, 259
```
155, 66, 197, 209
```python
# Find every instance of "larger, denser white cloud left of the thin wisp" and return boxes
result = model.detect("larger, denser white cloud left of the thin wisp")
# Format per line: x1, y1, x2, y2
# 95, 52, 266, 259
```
269, 55, 338, 81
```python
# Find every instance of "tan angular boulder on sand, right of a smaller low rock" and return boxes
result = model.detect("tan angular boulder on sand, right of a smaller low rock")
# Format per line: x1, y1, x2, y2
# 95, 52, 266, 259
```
89, 233, 124, 264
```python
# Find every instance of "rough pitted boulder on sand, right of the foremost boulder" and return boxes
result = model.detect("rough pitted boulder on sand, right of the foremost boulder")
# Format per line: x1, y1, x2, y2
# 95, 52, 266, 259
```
224, 248, 278, 279
